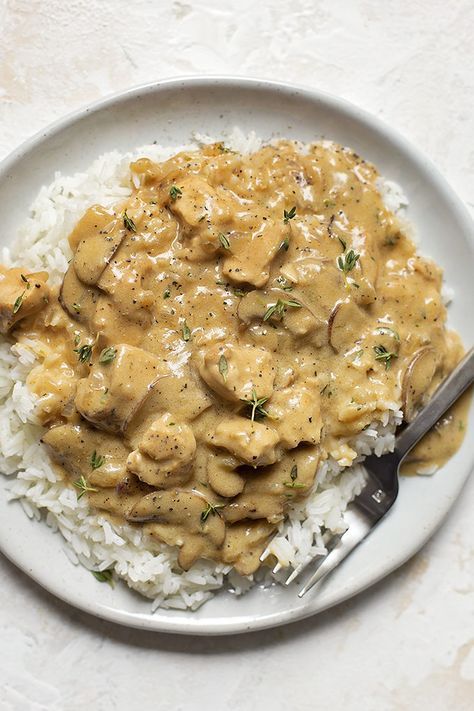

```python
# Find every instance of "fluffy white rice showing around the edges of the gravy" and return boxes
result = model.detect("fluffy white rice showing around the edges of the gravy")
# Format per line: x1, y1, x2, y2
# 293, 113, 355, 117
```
0, 130, 406, 609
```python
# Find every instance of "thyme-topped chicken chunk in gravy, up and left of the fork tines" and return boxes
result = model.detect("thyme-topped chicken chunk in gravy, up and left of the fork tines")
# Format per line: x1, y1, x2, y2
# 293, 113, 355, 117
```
223, 446, 320, 523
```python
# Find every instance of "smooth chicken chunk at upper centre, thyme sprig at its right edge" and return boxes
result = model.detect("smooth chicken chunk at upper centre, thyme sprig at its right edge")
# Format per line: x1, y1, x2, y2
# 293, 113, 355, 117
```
222, 222, 288, 288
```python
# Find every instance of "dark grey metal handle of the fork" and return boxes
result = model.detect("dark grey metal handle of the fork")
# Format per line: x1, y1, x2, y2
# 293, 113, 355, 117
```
395, 348, 474, 463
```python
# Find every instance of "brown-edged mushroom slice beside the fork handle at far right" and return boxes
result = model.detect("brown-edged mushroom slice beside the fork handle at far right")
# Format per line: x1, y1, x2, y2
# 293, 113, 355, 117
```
402, 346, 439, 422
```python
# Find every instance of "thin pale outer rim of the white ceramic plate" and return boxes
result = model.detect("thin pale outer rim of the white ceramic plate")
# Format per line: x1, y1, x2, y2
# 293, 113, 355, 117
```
0, 74, 474, 636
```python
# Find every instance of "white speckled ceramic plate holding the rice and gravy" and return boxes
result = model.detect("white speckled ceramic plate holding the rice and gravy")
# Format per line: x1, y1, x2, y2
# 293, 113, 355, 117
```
0, 77, 474, 634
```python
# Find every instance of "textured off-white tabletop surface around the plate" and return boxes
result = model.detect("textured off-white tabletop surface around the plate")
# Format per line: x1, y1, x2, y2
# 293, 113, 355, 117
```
0, 0, 474, 711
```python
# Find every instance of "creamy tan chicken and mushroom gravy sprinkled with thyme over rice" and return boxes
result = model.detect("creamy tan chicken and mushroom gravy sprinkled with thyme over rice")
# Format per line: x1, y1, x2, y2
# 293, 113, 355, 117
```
0, 142, 465, 573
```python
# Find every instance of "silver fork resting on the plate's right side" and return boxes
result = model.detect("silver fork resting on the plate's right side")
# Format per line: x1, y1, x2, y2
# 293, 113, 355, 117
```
282, 348, 474, 597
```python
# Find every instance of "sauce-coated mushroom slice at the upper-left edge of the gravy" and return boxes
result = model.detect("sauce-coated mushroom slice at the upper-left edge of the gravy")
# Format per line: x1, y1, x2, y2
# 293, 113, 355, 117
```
69, 205, 126, 286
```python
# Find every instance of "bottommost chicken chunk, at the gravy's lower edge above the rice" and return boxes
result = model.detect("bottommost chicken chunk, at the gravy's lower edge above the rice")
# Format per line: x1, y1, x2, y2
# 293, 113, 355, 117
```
222, 521, 275, 575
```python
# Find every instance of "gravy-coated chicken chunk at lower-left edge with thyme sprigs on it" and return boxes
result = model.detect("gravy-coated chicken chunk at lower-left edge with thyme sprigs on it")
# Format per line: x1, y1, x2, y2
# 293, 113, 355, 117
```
42, 424, 129, 487
